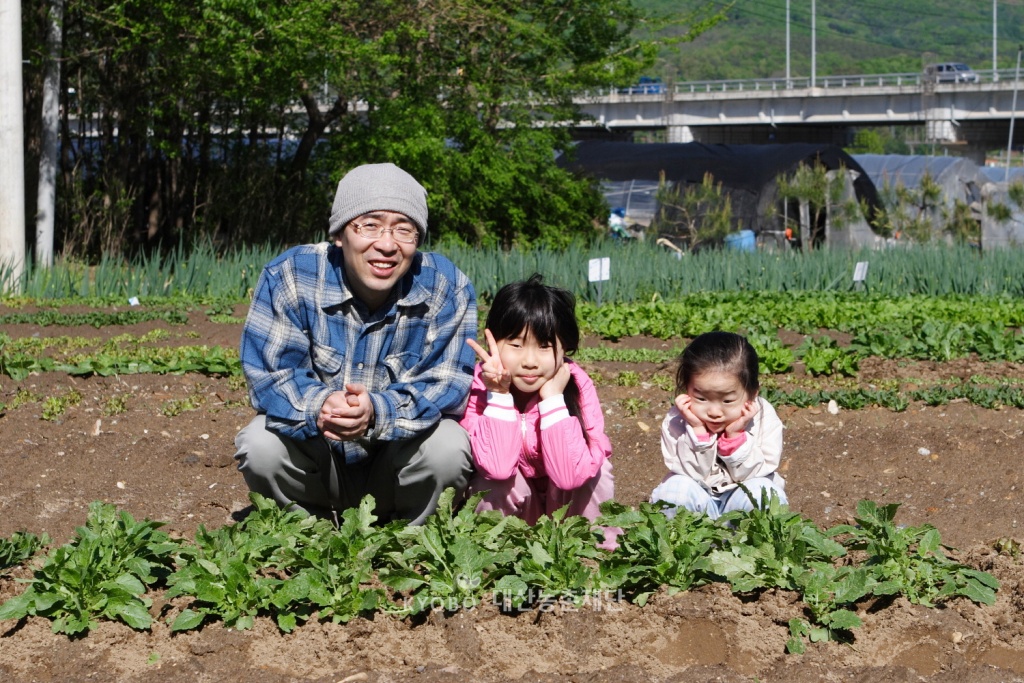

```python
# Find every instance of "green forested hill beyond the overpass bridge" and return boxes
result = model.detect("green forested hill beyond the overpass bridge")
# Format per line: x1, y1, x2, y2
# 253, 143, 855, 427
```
634, 0, 1024, 81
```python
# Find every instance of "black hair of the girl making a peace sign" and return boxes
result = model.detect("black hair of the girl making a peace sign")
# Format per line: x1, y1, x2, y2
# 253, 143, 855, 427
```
486, 272, 590, 441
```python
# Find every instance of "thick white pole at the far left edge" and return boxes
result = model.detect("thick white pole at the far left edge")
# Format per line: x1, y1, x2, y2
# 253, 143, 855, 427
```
0, 0, 25, 293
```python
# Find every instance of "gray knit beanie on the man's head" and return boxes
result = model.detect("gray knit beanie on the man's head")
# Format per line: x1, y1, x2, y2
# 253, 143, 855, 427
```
328, 164, 427, 243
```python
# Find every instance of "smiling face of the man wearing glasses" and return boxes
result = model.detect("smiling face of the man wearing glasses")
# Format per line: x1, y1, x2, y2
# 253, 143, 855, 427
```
334, 211, 418, 310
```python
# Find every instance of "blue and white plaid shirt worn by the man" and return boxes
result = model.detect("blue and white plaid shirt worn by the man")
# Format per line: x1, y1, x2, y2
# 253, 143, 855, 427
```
241, 243, 476, 462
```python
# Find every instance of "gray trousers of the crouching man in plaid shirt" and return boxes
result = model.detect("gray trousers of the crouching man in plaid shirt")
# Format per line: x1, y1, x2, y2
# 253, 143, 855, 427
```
234, 415, 473, 524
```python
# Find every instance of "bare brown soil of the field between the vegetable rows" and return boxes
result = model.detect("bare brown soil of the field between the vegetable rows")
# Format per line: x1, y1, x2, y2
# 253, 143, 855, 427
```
0, 309, 1024, 683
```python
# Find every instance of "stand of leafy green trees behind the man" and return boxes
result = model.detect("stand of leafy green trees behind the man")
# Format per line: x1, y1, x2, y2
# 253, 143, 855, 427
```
25, 0, 729, 257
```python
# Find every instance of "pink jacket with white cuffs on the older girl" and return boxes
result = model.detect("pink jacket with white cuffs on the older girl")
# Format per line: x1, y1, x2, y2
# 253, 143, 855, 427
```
461, 358, 611, 490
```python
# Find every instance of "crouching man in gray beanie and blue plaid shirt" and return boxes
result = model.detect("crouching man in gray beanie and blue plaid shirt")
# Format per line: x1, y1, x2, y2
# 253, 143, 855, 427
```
234, 164, 476, 524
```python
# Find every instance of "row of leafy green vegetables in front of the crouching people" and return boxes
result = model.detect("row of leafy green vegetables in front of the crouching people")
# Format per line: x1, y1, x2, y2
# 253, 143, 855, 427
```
0, 489, 998, 652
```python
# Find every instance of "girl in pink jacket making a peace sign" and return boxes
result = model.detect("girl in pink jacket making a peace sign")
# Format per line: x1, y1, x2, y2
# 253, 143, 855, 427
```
462, 274, 614, 528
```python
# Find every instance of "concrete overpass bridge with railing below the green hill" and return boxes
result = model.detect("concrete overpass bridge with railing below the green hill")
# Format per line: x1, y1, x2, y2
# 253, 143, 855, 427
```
575, 69, 1024, 163
